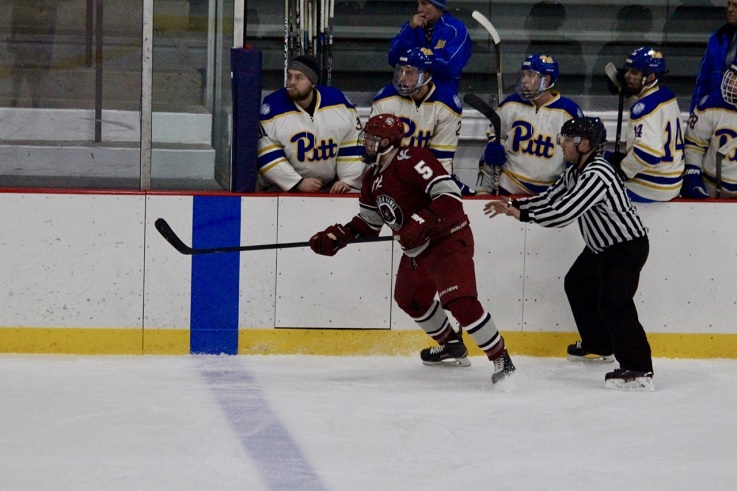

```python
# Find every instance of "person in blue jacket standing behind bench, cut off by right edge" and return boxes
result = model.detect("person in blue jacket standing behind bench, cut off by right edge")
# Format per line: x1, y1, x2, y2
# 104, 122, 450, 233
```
689, 0, 737, 113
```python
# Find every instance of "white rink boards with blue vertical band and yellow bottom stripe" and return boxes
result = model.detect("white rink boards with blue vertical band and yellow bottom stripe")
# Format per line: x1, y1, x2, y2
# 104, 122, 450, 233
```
0, 192, 737, 358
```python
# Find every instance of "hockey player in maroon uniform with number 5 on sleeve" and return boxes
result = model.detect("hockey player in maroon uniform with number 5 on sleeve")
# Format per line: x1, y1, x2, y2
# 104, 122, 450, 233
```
310, 114, 514, 383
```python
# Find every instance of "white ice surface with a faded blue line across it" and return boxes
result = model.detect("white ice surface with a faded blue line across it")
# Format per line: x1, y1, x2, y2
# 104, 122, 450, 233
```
0, 355, 737, 491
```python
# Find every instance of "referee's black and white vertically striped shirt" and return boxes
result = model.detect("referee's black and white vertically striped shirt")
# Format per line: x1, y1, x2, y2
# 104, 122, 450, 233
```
513, 156, 647, 253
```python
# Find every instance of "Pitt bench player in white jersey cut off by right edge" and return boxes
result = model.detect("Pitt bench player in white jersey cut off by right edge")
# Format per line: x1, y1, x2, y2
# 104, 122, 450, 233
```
681, 60, 737, 198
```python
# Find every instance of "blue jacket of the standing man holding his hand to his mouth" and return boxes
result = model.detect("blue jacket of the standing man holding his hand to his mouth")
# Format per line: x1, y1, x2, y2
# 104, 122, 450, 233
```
388, 12, 471, 94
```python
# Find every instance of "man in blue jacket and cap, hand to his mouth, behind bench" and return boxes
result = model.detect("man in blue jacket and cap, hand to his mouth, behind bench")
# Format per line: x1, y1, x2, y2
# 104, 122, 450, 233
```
388, 0, 468, 94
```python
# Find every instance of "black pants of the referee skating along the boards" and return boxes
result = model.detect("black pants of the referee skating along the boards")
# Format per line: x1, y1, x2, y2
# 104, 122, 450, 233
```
565, 237, 653, 372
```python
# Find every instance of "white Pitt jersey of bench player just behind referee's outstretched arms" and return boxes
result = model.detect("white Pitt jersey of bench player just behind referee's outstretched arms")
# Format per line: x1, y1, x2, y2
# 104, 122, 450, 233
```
477, 91, 583, 195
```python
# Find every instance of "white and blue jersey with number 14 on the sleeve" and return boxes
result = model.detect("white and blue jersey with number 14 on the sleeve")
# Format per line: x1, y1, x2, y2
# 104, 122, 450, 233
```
622, 85, 684, 201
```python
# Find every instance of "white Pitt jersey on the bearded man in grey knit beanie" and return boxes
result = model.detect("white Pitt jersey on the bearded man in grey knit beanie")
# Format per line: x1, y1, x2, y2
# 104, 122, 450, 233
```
258, 86, 366, 191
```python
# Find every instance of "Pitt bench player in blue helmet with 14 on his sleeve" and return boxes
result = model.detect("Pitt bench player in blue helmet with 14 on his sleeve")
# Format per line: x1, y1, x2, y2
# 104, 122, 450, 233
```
609, 46, 684, 202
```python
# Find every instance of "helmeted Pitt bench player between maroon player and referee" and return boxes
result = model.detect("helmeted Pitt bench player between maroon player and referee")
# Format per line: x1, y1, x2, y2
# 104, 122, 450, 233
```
476, 53, 583, 195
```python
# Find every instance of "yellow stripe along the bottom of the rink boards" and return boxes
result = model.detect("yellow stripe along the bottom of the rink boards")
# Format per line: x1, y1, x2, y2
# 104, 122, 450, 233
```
0, 327, 737, 359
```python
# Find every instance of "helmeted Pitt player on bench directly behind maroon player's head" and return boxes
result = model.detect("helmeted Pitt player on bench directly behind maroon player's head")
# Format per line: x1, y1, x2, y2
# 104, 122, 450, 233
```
371, 48, 462, 186
